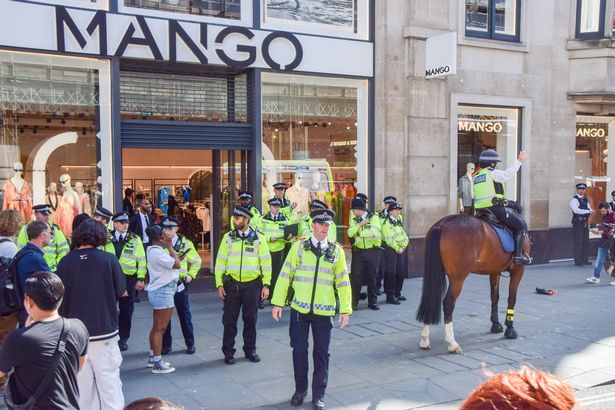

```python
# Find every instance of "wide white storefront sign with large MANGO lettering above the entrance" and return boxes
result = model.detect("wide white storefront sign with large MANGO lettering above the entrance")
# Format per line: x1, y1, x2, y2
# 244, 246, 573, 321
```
0, 0, 373, 77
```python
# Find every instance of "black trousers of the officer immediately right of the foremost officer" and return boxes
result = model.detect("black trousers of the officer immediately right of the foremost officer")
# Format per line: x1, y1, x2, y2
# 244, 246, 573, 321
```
350, 248, 381, 307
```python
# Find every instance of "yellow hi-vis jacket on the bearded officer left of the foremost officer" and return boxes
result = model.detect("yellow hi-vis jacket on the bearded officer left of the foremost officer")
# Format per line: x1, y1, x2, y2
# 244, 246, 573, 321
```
214, 229, 271, 288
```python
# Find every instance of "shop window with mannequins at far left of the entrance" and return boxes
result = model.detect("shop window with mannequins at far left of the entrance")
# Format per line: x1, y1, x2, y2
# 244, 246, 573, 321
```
0, 51, 105, 237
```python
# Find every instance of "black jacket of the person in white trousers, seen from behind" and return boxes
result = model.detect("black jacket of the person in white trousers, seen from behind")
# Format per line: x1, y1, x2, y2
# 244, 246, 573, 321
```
56, 248, 126, 341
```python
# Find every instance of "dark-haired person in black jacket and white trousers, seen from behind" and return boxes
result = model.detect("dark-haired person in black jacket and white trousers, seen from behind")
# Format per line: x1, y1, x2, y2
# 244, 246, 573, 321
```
58, 219, 126, 410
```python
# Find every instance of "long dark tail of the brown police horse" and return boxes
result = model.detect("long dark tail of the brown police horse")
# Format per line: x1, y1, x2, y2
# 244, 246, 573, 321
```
416, 225, 446, 325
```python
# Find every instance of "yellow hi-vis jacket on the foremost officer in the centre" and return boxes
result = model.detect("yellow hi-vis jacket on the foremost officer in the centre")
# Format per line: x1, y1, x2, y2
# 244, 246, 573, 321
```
271, 239, 352, 316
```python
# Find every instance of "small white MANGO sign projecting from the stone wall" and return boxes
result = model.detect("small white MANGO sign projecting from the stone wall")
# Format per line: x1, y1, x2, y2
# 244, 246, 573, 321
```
425, 32, 457, 80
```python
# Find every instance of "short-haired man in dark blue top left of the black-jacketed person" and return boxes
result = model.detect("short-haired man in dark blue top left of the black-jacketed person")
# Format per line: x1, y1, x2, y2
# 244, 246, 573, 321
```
13, 221, 51, 327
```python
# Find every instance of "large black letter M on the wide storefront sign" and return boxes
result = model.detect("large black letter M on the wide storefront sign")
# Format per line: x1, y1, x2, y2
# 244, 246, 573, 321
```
55, 6, 107, 55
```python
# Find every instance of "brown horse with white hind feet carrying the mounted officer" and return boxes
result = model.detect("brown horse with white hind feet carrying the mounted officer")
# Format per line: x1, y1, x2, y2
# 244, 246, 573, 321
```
416, 215, 530, 353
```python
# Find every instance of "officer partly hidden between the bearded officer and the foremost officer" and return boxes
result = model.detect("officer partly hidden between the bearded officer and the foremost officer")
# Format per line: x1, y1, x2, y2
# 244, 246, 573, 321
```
259, 198, 289, 302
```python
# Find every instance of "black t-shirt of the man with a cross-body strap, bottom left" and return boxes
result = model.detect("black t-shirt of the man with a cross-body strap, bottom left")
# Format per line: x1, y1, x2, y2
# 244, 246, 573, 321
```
0, 319, 89, 409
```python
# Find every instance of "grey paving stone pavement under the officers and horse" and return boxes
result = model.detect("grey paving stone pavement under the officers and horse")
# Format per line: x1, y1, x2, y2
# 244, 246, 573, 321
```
109, 263, 615, 410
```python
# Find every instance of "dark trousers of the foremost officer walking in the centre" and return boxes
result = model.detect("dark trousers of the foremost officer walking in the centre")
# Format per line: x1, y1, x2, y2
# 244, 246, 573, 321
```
289, 309, 333, 400
